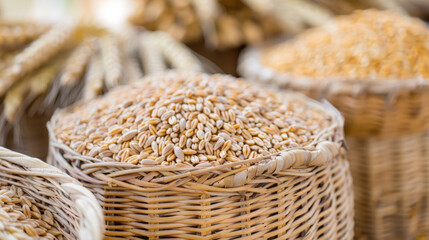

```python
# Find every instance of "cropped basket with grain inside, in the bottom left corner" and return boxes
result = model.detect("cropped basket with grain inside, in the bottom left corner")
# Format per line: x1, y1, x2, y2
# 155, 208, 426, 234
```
0, 147, 104, 240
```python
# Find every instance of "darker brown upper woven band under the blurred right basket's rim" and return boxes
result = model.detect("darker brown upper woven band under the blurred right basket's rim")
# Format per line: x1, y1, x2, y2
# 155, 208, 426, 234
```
327, 92, 429, 138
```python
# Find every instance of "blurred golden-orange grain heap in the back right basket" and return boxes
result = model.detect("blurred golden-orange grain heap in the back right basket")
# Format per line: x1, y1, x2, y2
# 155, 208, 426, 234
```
261, 10, 429, 80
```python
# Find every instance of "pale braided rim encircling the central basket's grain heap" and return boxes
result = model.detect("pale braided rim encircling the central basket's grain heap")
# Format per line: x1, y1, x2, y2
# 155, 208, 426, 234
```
47, 87, 345, 186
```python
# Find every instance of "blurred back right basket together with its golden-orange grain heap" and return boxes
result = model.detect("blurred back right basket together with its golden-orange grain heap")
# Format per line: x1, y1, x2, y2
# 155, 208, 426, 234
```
239, 10, 429, 239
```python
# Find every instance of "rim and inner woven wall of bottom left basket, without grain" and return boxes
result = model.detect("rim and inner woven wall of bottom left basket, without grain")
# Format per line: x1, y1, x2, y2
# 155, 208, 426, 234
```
0, 147, 104, 240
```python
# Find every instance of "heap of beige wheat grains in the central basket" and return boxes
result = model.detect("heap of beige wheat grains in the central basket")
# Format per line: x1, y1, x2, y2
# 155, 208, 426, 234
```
54, 73, 331, 165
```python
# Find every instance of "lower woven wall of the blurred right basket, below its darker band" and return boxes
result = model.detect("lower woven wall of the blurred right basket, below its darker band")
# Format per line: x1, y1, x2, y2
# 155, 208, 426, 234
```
347, 131, 429, 240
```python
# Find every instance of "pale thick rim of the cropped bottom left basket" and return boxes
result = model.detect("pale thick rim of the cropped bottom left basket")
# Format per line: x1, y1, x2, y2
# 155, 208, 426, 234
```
0, 147, 104, 240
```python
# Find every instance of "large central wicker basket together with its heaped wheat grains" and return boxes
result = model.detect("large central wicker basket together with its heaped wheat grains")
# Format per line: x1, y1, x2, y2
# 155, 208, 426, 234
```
48, 72, 353, 239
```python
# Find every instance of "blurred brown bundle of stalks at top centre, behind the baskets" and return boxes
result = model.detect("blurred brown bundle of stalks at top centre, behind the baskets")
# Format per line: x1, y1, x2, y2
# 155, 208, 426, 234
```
130, 0, 279, 48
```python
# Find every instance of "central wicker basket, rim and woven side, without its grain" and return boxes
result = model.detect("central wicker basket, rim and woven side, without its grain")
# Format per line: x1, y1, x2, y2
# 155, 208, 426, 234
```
48, 94, 354, 239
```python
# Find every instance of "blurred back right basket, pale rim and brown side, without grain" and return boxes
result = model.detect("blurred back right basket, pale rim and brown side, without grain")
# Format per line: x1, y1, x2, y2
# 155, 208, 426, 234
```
239, 48, 429, 239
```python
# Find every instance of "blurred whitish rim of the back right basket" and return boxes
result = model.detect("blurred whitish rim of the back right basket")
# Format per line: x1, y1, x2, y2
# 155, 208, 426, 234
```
237, 42, 429, 97
